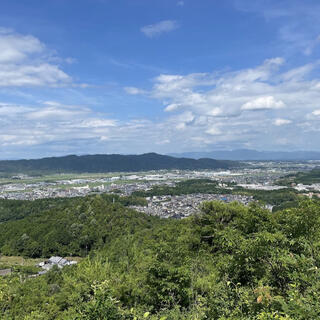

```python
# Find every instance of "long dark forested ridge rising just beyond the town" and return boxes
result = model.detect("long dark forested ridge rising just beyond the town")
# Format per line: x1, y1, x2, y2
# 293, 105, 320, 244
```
0, 153, 239, 173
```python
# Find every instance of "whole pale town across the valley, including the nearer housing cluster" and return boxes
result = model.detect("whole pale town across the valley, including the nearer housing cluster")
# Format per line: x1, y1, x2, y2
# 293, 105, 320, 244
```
0, 161, 320, 218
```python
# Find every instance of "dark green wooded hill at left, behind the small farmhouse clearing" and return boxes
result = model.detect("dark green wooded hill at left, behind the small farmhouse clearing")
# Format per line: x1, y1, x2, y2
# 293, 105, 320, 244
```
0, 195, 156, 258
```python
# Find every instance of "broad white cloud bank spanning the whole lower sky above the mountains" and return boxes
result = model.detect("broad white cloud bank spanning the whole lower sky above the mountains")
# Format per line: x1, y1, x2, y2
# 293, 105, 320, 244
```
0, 58, 320, 157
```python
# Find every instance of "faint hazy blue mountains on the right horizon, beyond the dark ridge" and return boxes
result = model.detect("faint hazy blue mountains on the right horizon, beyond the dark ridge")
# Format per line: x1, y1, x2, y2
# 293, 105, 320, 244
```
170, 149, 320, 161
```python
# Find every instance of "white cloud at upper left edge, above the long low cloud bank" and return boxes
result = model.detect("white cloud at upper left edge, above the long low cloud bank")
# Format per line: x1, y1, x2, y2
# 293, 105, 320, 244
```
0, 28, 72, 87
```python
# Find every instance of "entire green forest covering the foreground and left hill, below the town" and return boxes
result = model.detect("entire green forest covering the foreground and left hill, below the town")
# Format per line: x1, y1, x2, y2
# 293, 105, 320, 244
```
0, 195, 320, 320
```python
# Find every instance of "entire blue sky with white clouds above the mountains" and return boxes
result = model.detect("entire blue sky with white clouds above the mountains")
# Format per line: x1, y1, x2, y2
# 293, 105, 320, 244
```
0, 0, 320, 159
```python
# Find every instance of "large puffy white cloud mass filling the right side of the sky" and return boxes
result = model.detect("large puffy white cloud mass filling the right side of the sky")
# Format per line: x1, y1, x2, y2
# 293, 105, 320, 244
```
119, 58, 320, 150
